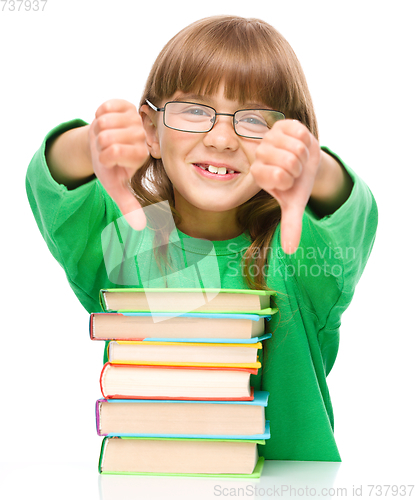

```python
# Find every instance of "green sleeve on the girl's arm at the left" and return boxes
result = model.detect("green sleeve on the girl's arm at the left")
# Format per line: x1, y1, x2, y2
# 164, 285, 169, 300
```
26, 120, 121, 312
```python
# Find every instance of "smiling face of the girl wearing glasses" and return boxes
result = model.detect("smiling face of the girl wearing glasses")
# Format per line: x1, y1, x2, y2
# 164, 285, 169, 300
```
141, 85, 262, 217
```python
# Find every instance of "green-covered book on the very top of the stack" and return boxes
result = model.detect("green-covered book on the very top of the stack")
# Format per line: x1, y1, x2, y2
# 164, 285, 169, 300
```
100, 288, 277, 314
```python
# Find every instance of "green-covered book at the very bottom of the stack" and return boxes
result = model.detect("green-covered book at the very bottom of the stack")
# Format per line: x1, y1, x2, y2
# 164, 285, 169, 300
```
98, 437, 265, 478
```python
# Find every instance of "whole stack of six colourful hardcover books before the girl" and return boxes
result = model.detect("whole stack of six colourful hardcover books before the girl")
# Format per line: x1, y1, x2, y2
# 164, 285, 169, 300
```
90, 288, 276, 477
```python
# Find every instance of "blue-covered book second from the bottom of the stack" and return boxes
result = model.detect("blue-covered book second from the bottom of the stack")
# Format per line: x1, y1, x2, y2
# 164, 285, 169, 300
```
96, 391, 270, 440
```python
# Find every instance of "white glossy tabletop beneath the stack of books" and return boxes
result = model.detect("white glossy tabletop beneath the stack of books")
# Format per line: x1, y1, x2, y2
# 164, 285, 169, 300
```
0, 457, 416, 500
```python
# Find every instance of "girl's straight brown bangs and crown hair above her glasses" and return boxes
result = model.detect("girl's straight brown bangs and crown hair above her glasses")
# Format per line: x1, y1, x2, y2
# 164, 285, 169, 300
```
142, 16, 315, 137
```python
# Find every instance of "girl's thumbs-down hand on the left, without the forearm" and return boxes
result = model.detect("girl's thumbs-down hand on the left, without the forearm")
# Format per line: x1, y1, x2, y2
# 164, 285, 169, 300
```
89, 99, 149, 230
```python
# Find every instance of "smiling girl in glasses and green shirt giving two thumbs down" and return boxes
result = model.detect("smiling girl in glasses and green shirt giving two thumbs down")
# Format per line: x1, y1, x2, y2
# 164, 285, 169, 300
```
27, 16, 377, 461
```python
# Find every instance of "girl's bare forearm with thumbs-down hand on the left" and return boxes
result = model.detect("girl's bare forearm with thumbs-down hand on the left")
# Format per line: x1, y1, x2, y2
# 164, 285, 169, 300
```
46, 99, 149, 230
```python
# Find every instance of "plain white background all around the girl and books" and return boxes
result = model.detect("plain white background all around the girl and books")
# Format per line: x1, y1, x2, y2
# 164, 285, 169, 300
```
0, 0, 416, 498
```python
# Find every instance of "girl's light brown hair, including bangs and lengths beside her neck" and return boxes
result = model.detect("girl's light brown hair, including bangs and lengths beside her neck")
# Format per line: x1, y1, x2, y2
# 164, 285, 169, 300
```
131, 16, 318, 289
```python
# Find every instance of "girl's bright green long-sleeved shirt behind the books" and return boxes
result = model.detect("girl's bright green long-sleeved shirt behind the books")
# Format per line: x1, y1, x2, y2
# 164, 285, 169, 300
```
26, 120, 377, 461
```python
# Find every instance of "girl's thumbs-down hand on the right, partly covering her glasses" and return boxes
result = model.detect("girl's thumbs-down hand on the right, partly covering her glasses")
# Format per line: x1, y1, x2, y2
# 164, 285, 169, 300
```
251, 120, 322, 253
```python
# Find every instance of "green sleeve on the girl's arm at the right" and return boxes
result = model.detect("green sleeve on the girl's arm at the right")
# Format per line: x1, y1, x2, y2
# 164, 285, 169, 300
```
275, 148, 378, 331
